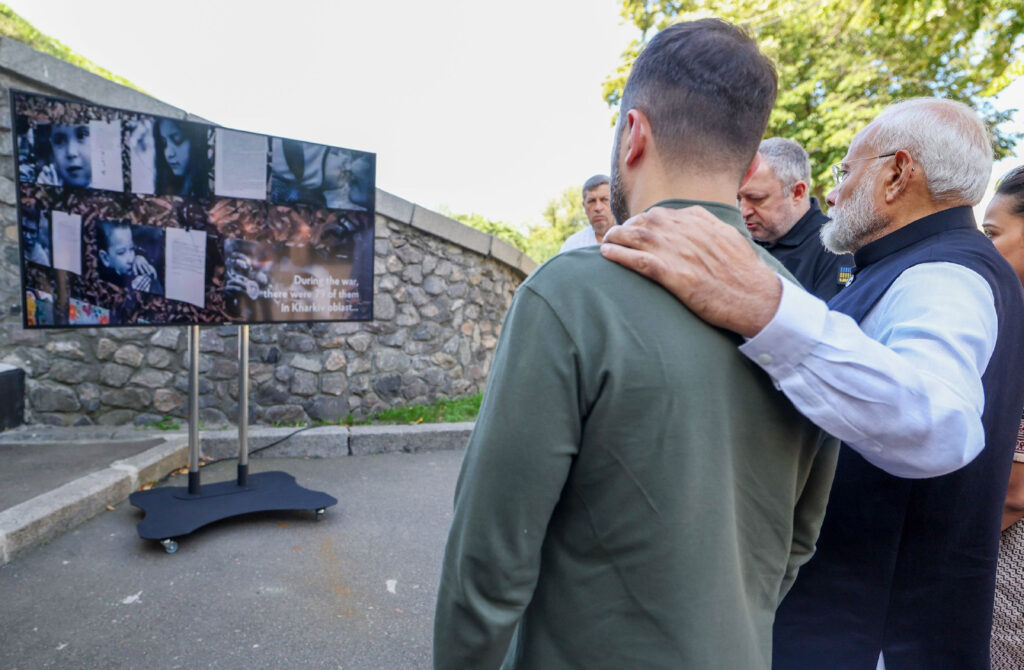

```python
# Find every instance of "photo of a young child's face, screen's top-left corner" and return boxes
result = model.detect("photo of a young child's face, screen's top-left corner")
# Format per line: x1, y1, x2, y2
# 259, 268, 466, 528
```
34, 123, 92, 189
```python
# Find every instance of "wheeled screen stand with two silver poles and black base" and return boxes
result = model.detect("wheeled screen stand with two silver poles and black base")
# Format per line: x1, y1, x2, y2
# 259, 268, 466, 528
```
129, 326, 338, 553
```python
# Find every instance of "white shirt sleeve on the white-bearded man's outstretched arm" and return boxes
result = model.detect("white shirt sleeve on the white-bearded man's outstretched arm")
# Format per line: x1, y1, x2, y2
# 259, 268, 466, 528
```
739, 262, 997, 477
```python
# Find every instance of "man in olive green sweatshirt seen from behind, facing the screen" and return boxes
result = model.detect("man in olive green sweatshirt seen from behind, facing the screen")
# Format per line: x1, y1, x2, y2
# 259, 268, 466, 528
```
434, 19, 838, 670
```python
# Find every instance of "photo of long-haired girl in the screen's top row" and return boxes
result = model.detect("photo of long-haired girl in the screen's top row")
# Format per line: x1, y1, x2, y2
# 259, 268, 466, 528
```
128, 119, 210, 198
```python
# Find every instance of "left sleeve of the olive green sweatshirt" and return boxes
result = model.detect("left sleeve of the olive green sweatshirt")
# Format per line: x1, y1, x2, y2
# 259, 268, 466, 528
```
434, 285, 583, 670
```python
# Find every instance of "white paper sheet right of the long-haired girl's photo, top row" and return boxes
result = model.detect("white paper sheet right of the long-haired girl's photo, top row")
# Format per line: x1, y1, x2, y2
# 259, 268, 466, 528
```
213, 128, 267, 200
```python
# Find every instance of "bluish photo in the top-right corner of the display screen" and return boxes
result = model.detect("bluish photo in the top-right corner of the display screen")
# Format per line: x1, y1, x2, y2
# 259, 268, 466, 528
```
269, 137, 374, 210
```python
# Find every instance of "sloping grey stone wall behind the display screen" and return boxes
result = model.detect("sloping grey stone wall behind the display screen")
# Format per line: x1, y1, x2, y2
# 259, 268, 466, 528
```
0, 38, 536, 425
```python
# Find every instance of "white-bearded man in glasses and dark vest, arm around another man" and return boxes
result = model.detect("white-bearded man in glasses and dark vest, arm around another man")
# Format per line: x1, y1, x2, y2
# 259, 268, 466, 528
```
602, 98, 1024, 670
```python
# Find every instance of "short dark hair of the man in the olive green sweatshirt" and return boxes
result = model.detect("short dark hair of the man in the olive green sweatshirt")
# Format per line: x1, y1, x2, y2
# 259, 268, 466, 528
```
620, 18, 778, 174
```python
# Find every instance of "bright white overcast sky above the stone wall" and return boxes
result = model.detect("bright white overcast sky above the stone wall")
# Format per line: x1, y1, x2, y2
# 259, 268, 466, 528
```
5, 0, 1024, 224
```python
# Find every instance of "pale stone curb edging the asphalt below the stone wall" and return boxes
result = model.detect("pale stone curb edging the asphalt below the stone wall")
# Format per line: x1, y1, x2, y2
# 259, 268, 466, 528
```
0, 422, 473, 566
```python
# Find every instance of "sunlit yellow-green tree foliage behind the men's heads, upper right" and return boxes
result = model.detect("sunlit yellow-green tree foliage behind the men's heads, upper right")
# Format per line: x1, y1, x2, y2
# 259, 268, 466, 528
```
604, 0, 1024, 194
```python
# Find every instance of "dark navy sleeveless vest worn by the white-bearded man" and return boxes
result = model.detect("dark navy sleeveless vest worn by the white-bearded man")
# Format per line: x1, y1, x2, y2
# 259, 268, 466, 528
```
772, 207, 1024, 670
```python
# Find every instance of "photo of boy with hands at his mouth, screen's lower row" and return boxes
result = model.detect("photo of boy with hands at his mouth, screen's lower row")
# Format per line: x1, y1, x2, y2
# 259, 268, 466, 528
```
96, 221, 164, 295
